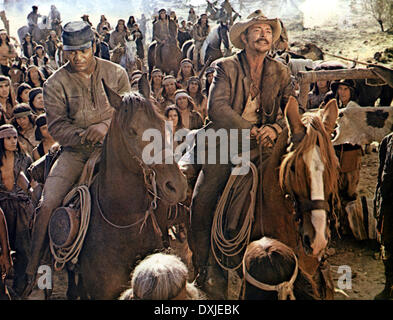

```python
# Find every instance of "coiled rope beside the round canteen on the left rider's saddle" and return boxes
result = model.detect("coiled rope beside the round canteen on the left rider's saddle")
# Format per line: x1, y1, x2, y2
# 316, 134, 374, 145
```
49, 185, 91, 271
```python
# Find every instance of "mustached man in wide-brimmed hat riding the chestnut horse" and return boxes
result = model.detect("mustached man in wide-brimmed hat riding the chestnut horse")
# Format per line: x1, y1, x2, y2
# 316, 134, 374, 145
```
189, 11, 294, 288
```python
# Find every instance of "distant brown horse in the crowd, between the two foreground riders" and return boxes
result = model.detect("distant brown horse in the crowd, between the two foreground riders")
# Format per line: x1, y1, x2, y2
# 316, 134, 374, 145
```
147, 39, 182, 76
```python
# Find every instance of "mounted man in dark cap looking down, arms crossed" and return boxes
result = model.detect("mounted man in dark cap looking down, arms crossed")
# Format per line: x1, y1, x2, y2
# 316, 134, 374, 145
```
24, 21, 131, 296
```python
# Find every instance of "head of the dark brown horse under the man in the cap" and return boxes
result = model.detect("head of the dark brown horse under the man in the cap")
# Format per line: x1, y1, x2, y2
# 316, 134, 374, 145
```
103, 74, 187, 204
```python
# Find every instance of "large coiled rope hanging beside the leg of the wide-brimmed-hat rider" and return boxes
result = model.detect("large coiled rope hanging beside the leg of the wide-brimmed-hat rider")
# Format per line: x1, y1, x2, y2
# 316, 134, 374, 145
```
210, 162, 258, 271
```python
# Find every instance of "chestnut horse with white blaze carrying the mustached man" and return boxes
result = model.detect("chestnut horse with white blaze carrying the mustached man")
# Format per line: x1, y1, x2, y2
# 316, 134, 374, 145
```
198, 97, 338, 299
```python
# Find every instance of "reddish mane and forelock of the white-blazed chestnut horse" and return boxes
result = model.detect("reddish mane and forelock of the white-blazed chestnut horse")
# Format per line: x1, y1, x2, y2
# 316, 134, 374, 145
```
279, 111, 339, 204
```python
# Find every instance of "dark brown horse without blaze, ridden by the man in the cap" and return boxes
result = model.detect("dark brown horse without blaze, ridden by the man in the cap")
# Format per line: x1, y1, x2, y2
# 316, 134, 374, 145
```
69, 75, 187, 299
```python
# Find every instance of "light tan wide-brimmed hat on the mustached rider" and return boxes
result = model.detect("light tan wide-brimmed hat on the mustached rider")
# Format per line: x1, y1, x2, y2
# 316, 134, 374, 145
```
229, 12, 281, 49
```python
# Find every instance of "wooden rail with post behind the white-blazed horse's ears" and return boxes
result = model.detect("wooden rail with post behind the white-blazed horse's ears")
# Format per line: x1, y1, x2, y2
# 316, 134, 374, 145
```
298, 68, 379, 109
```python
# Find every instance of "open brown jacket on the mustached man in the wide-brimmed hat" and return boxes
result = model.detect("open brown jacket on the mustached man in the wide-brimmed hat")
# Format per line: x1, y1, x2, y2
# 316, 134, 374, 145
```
208, 50, 295, 129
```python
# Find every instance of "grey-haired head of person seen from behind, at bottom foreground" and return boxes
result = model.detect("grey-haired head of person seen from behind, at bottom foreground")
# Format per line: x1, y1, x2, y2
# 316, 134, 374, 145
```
119, 253, 205, 300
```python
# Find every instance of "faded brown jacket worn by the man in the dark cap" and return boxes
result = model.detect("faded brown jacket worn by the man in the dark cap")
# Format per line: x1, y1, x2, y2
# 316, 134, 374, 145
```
43, 57, 131, 149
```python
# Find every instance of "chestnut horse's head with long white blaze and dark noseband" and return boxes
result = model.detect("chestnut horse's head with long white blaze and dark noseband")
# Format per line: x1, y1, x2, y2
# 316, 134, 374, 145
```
280, 97, 339, 257
